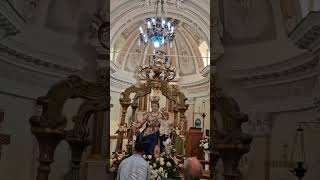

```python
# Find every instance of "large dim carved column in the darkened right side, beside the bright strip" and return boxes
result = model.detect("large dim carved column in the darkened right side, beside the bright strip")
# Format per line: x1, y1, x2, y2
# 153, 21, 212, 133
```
210, 87, 252, 180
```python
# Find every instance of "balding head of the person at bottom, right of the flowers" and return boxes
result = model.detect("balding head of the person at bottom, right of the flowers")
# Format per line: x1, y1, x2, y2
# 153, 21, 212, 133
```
183, 157, 203, 180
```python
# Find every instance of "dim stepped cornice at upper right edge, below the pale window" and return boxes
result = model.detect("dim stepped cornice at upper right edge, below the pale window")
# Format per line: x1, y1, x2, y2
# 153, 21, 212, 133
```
289, 11, 320, 51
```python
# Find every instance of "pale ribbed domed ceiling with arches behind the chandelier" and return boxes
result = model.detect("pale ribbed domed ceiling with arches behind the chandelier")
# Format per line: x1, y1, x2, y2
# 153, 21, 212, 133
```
110, 0, 210, 79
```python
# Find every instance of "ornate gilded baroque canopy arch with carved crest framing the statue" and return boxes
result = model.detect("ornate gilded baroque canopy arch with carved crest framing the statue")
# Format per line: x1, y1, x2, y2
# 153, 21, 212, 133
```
113, 51, 188, 171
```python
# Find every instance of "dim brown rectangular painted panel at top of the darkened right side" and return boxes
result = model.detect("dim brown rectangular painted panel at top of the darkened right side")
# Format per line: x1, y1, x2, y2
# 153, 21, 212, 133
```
221, 0, 276, 46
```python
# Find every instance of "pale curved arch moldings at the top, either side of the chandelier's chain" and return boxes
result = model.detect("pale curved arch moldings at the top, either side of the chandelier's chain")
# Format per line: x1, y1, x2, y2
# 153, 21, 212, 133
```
110, 1, 210, 47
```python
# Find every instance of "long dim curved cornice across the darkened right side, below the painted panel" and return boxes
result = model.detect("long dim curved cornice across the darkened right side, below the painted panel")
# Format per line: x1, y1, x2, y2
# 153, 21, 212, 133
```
231, 52, 319, 88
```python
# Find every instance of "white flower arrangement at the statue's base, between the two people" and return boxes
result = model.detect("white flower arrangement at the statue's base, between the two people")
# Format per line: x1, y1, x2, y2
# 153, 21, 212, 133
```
143, 153, 182, 180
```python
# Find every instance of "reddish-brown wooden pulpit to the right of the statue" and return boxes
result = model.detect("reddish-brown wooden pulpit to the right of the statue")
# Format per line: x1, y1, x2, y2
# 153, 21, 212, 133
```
186, 127, 204, 160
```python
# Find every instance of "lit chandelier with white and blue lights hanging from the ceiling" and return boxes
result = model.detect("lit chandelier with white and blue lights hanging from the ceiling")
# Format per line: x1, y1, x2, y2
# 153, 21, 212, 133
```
138, 0, 176, 50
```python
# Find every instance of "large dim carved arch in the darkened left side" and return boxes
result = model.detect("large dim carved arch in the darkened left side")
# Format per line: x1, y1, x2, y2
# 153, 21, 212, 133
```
30, 76, 110, 180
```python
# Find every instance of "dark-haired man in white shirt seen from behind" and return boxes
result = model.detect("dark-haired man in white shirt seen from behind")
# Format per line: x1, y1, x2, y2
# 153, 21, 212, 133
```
117, 142, 151, 180
